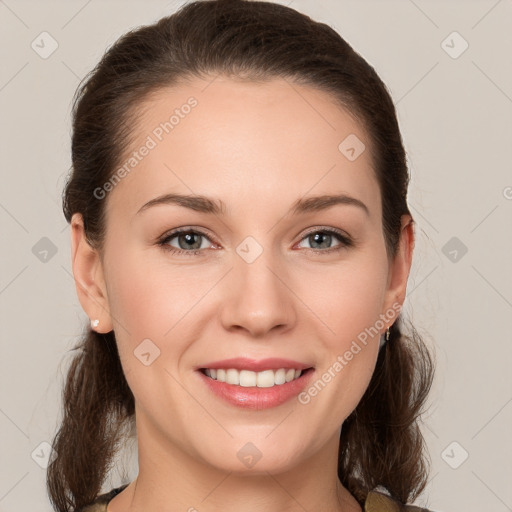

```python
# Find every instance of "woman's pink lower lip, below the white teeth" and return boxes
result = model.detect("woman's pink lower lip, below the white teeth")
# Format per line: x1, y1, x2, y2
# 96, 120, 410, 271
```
197, 368, 314, 410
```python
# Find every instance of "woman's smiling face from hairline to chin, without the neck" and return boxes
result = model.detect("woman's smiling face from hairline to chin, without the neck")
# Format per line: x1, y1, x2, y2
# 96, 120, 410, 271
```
71, 77, 412, 472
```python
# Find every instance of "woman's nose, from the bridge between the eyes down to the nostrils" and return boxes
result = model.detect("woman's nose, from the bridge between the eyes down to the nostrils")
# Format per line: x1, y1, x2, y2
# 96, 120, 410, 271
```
222, 237, 294, 336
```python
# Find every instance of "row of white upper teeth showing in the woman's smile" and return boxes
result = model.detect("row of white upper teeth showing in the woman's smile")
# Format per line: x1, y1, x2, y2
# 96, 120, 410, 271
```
204, 368, 302, 388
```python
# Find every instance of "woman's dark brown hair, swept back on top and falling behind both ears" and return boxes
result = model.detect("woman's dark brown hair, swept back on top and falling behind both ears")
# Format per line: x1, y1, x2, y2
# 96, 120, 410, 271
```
47, 0, 434, 512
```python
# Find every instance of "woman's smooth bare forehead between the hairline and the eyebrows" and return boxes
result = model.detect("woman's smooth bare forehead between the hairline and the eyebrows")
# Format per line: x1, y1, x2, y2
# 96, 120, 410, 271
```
107, 76, 380, 216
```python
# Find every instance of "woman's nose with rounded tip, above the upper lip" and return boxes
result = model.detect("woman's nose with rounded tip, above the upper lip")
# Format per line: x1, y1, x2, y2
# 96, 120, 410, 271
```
221, 246, 297, 338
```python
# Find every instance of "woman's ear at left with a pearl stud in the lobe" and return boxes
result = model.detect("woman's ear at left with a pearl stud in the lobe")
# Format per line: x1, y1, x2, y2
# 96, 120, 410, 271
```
71, 213, 113, 333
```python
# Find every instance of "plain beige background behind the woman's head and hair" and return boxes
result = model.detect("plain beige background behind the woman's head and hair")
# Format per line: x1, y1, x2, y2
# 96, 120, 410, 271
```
0, 0, 512, 512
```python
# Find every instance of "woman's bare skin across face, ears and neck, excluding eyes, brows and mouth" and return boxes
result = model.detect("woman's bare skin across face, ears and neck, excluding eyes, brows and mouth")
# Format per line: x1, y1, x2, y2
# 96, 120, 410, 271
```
71, 76, 414, 512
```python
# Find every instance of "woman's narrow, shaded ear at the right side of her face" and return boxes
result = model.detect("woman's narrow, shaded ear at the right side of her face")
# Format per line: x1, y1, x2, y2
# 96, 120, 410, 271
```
384, 215, 414, 330
